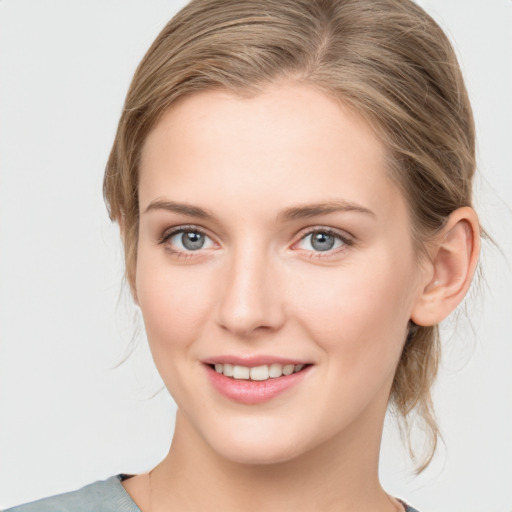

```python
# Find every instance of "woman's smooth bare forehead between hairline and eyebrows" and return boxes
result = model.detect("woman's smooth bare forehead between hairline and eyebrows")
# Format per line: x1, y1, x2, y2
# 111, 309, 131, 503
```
139, 84, 400, 220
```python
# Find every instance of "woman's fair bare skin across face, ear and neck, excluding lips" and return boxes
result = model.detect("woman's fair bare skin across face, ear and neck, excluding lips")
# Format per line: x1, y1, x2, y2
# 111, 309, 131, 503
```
124, 83, 476, 512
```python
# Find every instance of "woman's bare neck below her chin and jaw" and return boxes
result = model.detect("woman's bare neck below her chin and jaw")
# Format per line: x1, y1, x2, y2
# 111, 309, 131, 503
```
151, 413, 397, 512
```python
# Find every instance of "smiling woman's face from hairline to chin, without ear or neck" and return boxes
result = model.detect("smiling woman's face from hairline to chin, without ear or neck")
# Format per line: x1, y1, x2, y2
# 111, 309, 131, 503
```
135, 84, 425, 463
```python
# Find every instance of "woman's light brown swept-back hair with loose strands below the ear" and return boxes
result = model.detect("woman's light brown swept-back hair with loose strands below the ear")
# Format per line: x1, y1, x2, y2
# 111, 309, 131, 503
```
104, 0, 475, 472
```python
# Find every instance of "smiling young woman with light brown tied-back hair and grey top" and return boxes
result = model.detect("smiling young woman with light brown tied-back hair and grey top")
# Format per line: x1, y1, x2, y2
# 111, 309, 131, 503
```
3, 0, 480, 512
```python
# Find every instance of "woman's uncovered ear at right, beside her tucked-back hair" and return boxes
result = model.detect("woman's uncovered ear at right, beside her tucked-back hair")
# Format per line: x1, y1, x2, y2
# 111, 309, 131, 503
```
411, 206, 480, 326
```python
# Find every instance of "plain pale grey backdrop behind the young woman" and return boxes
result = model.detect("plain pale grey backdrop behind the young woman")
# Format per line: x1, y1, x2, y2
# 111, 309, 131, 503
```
0, 0, 512, 512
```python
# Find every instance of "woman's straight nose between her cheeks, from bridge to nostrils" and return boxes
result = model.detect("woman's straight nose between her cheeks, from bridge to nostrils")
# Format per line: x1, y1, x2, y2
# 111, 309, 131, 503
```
217, 243, 285, 337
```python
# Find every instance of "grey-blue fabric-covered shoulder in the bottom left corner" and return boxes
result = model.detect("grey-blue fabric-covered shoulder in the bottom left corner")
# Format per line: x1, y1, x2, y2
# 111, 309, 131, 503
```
4, 475, 140, 512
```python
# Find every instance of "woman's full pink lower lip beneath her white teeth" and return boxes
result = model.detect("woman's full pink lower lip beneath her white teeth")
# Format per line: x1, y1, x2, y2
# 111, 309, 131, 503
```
205, 365, 312, 405
